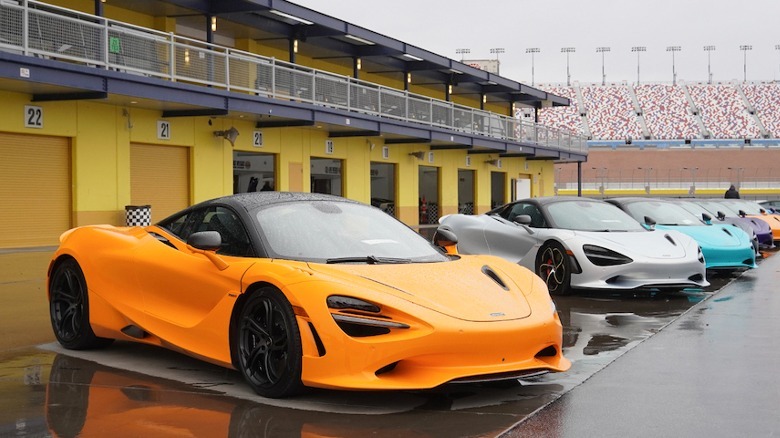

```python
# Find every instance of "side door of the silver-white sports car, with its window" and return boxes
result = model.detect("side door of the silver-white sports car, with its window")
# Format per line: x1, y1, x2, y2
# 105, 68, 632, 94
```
484, 202, 541, 262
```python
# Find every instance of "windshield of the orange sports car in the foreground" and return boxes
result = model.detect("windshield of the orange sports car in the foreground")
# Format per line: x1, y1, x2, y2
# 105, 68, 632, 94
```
255, 201, 448, 263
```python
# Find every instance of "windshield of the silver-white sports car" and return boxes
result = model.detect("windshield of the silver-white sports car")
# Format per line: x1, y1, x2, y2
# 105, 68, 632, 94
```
547, 201, 646, 231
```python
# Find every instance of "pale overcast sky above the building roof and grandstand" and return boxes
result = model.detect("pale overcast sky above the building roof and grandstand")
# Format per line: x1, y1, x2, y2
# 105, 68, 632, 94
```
291, 0, 780, 84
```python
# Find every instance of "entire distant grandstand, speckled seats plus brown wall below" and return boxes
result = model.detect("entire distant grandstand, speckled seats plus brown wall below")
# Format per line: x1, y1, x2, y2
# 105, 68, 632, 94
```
538, 81, 780, 198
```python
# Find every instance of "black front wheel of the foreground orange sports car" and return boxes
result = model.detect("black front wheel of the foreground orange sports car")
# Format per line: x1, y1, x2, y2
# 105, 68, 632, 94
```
233, 287, 303, 398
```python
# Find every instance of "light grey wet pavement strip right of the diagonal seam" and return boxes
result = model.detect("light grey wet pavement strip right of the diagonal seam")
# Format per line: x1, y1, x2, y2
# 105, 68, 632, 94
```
503, 252, 780, 438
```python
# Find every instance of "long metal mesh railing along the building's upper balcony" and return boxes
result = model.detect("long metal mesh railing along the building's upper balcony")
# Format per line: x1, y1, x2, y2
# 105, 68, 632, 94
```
0, 0, 588, 154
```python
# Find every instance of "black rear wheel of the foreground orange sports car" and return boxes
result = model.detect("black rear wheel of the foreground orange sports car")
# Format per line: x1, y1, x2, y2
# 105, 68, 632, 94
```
49, 259, 114, 350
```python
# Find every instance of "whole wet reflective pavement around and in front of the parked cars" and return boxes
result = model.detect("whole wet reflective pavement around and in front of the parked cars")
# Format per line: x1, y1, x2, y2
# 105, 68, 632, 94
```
0, 248, 780, 437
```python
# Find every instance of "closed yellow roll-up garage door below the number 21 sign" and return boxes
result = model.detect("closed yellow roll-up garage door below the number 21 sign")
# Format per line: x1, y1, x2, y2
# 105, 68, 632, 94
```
130, 143, 190, 223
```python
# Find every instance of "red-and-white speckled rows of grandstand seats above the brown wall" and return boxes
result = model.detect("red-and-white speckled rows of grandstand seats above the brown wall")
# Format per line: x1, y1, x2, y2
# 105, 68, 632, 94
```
539, 83, 780, 142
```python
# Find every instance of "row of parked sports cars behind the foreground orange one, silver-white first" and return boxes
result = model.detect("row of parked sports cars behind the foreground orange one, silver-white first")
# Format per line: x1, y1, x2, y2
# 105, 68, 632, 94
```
439, 197, 780, 294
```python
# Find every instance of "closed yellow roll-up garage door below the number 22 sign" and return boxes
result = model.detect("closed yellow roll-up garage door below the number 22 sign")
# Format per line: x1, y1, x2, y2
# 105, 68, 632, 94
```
0, 133, 73, 248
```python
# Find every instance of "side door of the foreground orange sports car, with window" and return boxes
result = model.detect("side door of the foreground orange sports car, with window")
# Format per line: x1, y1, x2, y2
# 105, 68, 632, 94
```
135, 207, 255, 352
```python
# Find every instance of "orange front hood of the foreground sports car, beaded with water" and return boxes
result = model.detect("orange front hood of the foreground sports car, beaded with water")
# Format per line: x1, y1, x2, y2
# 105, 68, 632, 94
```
310, 256, 537, 321
